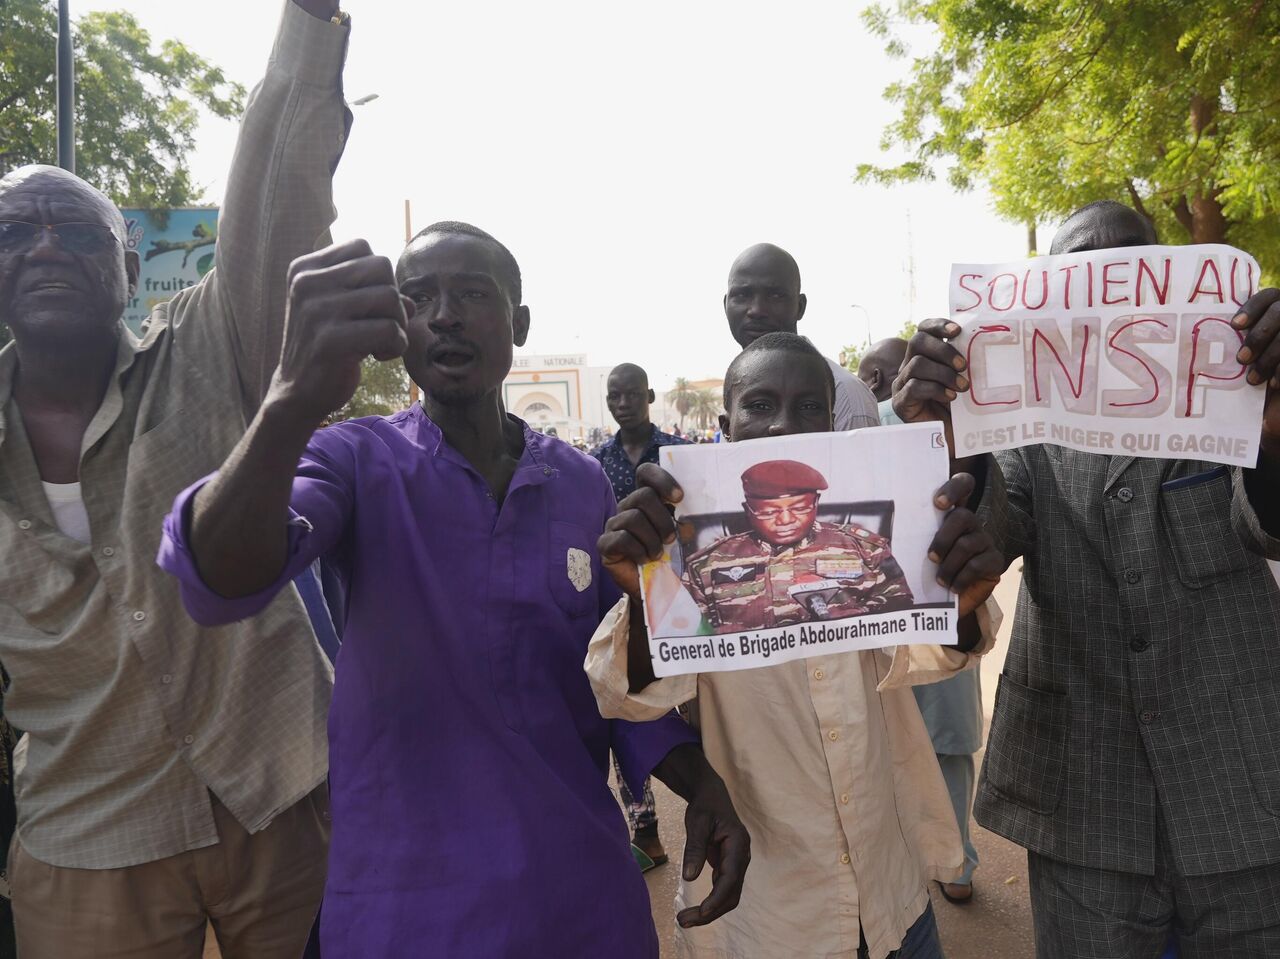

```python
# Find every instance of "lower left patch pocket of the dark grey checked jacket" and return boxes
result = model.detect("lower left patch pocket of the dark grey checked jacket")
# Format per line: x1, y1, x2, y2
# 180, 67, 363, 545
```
984, 675, 1071, 814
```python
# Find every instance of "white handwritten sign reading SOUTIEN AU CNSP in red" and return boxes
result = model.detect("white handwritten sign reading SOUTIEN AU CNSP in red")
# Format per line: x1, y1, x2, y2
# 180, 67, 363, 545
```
950, 245, 1265, 466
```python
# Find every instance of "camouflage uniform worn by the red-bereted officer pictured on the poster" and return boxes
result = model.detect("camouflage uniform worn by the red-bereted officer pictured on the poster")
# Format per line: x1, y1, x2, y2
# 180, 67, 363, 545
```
684, 522, 914, 633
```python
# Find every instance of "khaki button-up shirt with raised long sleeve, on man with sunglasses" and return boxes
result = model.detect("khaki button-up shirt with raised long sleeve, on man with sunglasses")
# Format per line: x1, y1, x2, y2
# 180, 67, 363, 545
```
0, 3, 348, 869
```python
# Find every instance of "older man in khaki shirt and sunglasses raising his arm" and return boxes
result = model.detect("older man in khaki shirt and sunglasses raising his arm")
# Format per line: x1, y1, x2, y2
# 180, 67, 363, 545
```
0, 0, 348, 959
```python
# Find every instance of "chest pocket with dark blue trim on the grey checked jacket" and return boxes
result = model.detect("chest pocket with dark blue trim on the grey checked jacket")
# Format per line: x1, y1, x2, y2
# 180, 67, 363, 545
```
1160, 466, 1249, 589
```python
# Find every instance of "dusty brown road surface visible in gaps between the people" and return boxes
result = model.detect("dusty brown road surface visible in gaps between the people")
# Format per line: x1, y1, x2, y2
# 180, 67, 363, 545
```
645, 574, 1036, 959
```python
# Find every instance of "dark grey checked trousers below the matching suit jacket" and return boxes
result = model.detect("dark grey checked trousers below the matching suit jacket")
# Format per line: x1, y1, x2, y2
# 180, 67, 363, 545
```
1027, 850, 1280, 959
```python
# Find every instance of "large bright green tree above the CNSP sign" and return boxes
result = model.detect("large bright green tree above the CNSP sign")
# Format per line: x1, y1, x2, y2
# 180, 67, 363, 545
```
858, 0, 1280, 275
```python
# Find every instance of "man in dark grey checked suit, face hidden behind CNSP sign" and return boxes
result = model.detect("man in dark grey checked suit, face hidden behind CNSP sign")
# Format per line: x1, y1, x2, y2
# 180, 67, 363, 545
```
893, 202, 1280, 959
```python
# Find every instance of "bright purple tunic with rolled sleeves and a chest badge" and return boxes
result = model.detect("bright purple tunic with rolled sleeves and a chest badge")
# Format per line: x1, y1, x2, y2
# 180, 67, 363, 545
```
163, 406, 695, 959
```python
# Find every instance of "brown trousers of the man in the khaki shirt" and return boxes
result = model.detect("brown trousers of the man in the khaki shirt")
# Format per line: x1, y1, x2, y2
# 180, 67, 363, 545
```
9, 786, 329, 959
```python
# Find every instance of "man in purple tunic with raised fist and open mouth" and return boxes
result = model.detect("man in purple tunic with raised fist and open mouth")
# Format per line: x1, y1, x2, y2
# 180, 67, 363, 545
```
160, 223, 750, 959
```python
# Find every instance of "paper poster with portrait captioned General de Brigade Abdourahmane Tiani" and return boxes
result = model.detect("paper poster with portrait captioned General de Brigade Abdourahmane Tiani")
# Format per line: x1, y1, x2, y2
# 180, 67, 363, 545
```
641, 424, 956, 676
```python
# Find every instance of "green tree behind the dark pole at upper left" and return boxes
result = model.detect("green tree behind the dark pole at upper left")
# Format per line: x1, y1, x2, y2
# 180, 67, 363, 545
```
0, 0, 244, 207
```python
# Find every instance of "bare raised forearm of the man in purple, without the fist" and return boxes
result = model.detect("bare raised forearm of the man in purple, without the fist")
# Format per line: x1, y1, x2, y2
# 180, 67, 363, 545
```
188, 399, 316, 599
